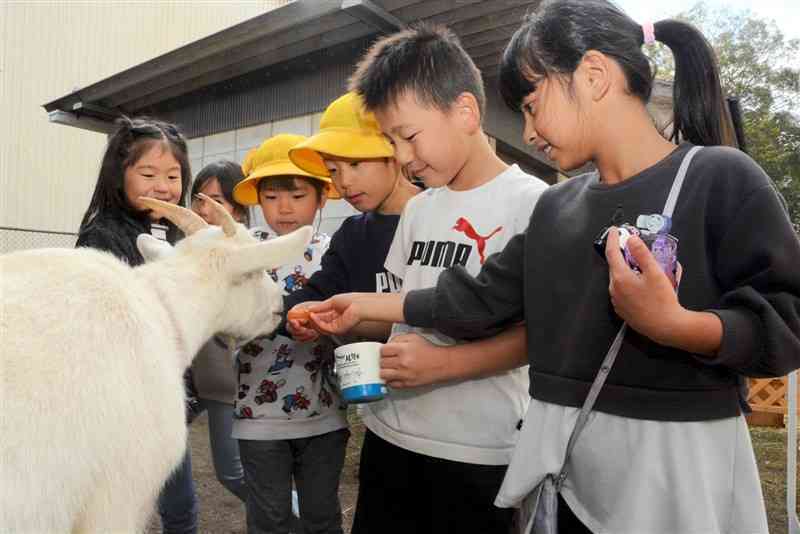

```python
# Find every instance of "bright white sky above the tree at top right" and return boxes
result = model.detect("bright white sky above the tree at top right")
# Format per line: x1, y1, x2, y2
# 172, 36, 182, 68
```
614, 0, 800, 38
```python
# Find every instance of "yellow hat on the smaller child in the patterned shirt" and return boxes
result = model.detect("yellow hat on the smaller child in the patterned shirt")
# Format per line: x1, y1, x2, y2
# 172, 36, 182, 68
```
233, 134, 340, 206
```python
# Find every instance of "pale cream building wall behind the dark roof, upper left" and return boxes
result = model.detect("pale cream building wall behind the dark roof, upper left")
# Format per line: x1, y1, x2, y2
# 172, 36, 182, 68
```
0, 0, 289, 252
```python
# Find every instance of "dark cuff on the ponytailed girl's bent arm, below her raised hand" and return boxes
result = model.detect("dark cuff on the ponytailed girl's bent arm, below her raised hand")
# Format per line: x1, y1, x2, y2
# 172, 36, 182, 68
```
701, 309, 764, 369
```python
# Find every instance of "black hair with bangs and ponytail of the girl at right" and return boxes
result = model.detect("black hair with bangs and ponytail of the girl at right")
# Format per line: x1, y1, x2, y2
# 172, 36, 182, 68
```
499, 0, 737, 150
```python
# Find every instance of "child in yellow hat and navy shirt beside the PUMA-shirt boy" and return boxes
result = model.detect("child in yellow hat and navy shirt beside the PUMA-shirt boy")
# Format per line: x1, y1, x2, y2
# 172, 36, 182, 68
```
284, 93, 419, 341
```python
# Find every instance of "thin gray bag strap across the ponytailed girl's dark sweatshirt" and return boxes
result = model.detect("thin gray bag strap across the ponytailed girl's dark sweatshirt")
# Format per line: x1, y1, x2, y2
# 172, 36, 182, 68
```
555, 146, 702, 490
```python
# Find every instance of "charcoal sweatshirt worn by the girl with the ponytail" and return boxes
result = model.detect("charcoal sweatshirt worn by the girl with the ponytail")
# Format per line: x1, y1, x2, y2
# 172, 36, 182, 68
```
404, 144, 800, 421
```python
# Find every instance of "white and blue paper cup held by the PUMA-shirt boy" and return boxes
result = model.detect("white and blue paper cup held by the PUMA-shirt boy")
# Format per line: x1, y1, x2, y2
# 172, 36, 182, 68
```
333, 341, 386, 404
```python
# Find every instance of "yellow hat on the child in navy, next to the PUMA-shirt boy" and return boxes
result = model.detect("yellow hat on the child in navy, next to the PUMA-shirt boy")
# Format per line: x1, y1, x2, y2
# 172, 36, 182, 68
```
289, 93, 394, 176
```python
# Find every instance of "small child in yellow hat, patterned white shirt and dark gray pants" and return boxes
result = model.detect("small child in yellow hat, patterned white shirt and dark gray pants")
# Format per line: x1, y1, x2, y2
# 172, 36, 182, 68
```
232, 134, 350, 532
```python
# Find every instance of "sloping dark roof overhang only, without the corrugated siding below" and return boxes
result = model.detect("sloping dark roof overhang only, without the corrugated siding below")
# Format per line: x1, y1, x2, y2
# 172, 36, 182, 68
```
44, 0, 540, 122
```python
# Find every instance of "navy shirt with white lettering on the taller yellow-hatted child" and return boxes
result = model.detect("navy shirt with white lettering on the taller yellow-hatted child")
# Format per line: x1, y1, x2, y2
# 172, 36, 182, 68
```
284, 212, 400, 311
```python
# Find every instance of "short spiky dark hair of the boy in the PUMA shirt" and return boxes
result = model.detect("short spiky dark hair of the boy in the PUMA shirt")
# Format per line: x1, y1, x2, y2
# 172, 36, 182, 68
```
349, 23, 486, 117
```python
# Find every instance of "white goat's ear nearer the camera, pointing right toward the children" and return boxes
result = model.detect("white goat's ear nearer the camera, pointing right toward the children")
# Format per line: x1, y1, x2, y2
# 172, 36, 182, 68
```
231, 226, 314, 276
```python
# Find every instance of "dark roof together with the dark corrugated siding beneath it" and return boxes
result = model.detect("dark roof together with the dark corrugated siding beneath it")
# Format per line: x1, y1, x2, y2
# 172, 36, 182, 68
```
44, 0, 555, 179
